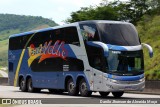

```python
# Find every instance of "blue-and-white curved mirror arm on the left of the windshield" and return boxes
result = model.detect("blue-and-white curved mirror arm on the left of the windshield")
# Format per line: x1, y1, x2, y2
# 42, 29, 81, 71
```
86, 41, 108, 57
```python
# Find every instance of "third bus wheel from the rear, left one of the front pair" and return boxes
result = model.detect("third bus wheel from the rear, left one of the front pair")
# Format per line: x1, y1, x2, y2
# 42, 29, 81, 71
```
67, 78, 78, 96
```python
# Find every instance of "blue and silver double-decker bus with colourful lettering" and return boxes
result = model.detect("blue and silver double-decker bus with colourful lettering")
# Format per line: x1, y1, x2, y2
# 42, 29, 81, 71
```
8, 20, 153, 97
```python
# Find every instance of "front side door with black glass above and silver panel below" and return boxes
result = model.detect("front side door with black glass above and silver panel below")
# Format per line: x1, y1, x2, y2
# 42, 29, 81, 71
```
87, 46, 104, 90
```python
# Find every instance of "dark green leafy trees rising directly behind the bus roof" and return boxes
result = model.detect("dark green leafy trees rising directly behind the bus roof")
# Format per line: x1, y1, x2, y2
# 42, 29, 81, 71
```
66, 0, 149, 24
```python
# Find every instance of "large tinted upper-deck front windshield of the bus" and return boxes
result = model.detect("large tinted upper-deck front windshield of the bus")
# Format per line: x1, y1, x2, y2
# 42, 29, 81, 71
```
98, 23, 140, 46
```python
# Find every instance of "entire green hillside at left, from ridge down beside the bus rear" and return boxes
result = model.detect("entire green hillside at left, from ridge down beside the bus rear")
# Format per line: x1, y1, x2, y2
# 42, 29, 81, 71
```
0, 14, 57, 66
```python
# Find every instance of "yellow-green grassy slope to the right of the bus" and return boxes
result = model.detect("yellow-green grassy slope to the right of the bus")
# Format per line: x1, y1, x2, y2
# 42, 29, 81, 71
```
137, 15, 160, 80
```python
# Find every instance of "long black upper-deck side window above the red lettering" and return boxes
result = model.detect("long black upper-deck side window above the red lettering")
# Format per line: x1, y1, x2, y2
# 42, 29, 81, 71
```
9, 26, 80, 50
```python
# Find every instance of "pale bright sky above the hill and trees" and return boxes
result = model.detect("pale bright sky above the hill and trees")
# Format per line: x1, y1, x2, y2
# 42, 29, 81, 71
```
0, 0, 127, 25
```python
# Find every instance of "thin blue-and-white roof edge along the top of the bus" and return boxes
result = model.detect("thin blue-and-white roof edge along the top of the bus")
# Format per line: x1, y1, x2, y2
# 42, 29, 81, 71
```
9, 20, 130, 38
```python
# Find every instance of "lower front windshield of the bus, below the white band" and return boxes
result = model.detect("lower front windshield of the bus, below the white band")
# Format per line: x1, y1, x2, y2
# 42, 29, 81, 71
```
106, 50, 144, 76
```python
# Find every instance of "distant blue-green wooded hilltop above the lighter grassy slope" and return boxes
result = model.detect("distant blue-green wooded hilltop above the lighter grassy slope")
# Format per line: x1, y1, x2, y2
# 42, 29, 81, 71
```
0, 14, 57, 32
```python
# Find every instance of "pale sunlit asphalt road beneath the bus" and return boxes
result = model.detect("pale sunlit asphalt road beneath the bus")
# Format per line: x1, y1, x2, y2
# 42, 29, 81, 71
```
0, 86, 160, 107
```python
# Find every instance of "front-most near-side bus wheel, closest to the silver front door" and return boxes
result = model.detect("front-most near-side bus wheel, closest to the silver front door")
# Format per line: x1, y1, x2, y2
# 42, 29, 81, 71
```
79, 79, 92, 97
